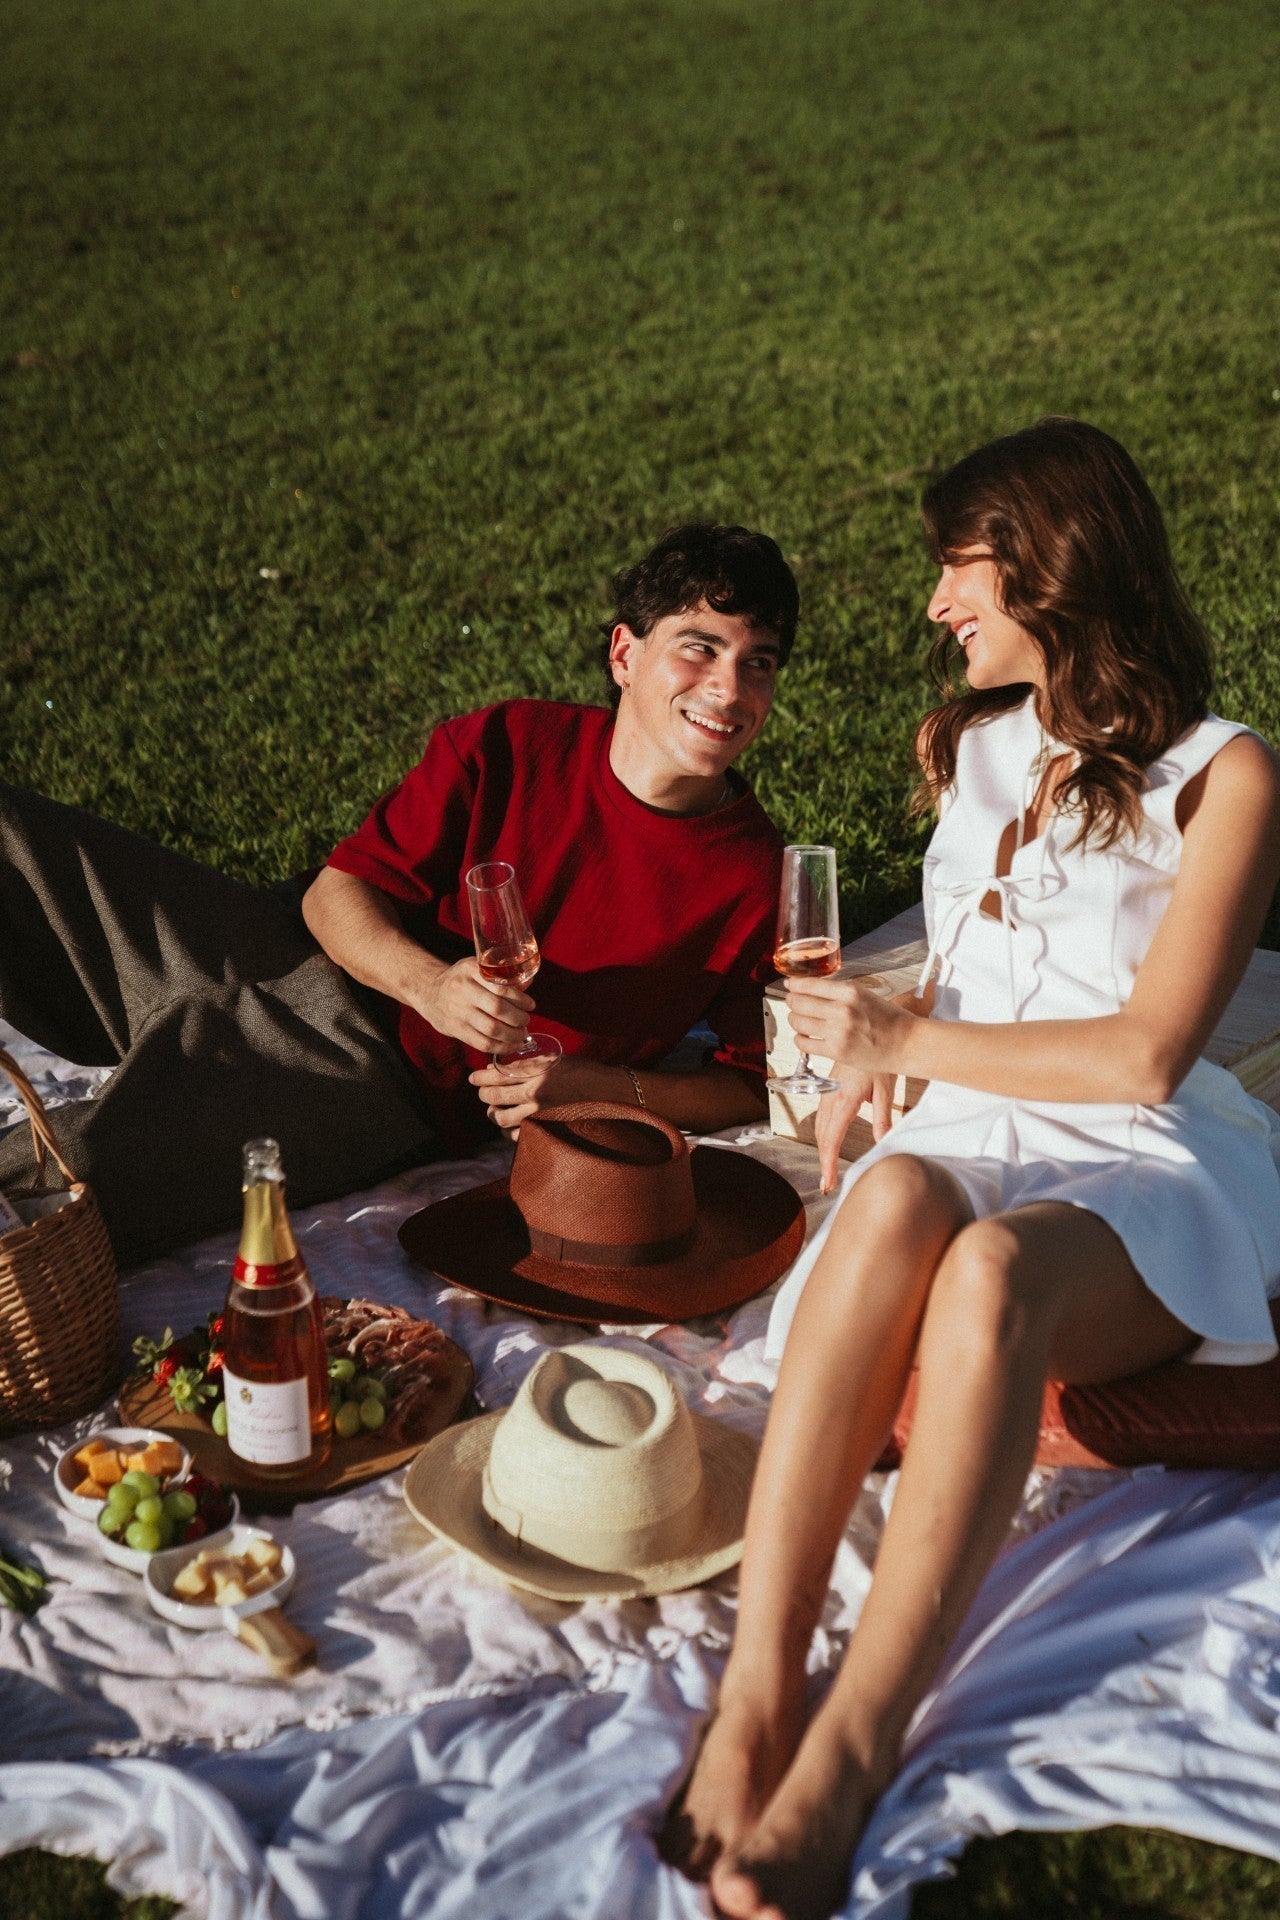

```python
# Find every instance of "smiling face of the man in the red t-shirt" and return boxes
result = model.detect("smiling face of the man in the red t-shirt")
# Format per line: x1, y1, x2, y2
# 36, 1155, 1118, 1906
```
608, 603, 779, 804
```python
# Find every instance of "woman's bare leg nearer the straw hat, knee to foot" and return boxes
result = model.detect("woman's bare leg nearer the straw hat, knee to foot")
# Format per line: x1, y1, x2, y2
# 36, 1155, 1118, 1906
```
662, 1154, 971, 1876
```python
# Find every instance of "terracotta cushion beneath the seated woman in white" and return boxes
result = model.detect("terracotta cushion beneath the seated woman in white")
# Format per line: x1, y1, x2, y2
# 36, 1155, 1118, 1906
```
879, 1302, 1280, 1469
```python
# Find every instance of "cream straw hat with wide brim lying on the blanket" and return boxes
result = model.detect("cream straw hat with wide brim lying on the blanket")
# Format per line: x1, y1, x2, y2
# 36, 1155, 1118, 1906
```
405, 1344, 756, 1599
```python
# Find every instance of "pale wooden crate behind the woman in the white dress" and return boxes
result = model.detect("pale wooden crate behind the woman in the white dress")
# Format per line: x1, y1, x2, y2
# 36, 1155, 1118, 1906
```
764, 906, 1280, 1160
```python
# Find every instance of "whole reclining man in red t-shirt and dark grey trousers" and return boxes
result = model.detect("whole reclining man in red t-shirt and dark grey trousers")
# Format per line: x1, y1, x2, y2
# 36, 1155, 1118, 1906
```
0, 526, 798, 1263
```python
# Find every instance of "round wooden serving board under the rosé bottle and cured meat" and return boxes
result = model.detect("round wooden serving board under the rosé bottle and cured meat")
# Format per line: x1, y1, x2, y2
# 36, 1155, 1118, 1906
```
117, 1340, 476, 1513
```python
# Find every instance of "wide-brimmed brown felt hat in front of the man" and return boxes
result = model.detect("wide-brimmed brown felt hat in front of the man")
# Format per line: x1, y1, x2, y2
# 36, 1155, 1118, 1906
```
399, 1100, 804, 1325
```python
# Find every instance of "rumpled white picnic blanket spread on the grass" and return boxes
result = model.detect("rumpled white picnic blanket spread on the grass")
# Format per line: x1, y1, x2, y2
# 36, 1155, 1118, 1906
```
0, 1033, 1280, 1920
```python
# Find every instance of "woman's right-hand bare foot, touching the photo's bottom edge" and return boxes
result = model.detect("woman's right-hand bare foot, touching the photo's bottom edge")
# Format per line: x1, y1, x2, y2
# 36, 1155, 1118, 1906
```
710, 1713, 890, 1920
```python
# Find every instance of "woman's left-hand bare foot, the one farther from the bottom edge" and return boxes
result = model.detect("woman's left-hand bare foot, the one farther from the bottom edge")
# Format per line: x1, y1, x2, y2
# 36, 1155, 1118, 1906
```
658, 1676, 804, 1880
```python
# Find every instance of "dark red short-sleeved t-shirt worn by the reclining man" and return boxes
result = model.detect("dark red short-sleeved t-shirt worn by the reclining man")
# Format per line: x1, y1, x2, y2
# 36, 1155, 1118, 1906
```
328, 701, 783, 1152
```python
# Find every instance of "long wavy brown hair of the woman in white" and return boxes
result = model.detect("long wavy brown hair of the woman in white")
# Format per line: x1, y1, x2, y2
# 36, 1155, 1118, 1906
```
912, 419, 1213, 847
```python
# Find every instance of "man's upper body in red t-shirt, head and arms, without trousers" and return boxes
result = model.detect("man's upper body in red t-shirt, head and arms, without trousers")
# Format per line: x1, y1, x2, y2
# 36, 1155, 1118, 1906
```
303, 526, 798, 1152
